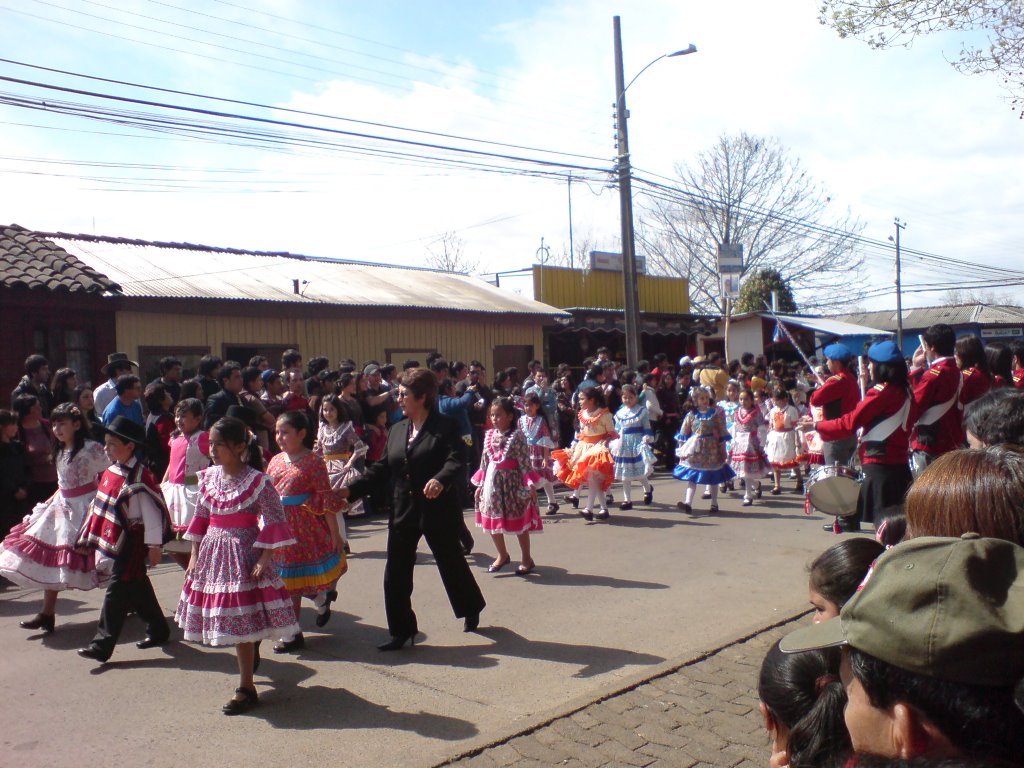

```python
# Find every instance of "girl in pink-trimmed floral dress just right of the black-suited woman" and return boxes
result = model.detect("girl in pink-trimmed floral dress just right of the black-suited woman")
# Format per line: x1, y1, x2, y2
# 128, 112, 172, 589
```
472, 397, 544, 575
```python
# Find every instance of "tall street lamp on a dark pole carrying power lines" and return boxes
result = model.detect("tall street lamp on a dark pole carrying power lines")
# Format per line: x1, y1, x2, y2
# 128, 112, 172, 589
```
612, 16, 697, 369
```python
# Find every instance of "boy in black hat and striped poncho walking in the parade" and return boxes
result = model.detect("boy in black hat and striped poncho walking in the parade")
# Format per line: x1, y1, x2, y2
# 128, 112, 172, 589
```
78, 416, 170, 663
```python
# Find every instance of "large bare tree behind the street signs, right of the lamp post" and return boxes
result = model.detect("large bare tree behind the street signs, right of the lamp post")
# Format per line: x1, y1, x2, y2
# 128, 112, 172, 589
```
634, 133, 863, 312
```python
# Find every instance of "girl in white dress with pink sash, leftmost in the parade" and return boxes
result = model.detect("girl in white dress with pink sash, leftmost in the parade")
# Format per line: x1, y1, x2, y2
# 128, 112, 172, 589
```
0, 402, 111, 634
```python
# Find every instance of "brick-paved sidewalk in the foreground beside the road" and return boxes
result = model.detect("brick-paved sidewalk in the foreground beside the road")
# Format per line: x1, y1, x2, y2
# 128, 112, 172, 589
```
443, 617, 806, 768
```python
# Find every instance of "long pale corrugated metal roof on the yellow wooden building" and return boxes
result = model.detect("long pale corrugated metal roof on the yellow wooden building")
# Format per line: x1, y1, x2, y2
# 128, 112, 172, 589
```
46, 232, 567, 316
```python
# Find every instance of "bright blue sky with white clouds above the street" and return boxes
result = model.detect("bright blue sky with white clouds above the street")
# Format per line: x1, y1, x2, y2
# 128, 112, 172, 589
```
0, 0, 1024, 309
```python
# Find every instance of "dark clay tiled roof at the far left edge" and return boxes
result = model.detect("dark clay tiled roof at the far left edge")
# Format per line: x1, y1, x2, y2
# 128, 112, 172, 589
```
0, 224, 120, 294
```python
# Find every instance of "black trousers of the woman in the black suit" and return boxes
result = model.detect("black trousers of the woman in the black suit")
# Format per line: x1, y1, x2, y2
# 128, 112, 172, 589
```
384, 526, 486, 637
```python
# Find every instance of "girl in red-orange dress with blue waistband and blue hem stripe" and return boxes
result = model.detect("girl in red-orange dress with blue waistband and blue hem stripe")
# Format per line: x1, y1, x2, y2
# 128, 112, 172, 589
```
266, 411, 348, 653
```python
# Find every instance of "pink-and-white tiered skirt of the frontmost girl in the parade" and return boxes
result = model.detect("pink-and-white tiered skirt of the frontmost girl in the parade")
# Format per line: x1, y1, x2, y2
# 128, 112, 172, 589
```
174, 526, 299, 645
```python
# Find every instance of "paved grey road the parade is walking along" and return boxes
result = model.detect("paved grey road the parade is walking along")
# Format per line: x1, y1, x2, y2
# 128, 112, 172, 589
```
0, 478, 833, 768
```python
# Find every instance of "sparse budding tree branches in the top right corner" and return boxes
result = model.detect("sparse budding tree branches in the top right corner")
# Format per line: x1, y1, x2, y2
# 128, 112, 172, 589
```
819, 0, 1024, 104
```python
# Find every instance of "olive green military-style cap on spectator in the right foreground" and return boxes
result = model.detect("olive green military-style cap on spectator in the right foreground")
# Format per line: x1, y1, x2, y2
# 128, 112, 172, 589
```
780, 534, 1024, 687
